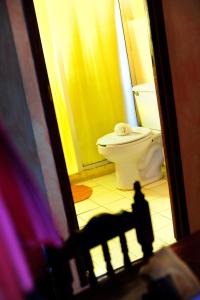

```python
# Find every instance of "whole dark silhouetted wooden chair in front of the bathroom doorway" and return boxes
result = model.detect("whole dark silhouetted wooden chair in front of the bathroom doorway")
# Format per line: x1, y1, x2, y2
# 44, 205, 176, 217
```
43, 182, 154, 299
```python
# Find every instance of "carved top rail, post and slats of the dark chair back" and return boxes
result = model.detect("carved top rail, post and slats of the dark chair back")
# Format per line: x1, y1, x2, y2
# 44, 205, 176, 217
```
45, 182, 154, 297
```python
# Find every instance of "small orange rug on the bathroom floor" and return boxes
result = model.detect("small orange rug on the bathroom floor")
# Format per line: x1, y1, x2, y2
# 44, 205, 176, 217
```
71, 184, 92, 203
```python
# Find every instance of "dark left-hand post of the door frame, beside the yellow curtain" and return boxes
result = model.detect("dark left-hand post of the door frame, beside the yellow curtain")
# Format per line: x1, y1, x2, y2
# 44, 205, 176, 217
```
22, 0, 79, 233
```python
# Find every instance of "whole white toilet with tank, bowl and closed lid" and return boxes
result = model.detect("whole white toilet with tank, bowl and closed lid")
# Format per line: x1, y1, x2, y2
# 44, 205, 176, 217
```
97, 84, 163, 190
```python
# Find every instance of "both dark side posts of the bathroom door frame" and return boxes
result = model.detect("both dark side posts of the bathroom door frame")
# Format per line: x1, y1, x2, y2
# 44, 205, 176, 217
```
22, 0, 190, 239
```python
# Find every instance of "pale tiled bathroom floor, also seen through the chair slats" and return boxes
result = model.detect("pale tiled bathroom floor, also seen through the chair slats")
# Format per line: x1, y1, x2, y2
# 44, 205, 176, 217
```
75, 173, 175, 276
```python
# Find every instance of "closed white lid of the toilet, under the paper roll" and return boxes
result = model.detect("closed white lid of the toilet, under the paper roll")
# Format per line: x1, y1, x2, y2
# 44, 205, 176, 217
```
97, 127, 151, 146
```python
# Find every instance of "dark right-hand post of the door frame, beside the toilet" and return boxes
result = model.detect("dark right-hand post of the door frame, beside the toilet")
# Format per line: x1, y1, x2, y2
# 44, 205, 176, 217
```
146, 0, 190, 240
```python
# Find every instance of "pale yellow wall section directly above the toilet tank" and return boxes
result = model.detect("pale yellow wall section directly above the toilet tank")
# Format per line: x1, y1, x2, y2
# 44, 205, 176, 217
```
120, 0, 154, 85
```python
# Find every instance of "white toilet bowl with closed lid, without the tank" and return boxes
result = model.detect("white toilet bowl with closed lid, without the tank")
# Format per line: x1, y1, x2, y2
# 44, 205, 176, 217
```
97, 127, 163, 190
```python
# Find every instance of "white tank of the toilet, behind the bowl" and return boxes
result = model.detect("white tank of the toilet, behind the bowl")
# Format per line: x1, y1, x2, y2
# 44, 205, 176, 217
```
132, 83, 161, 130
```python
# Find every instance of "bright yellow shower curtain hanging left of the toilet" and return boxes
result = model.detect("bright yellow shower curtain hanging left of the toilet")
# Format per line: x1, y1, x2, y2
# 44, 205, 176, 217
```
34, 0, 126, 174
